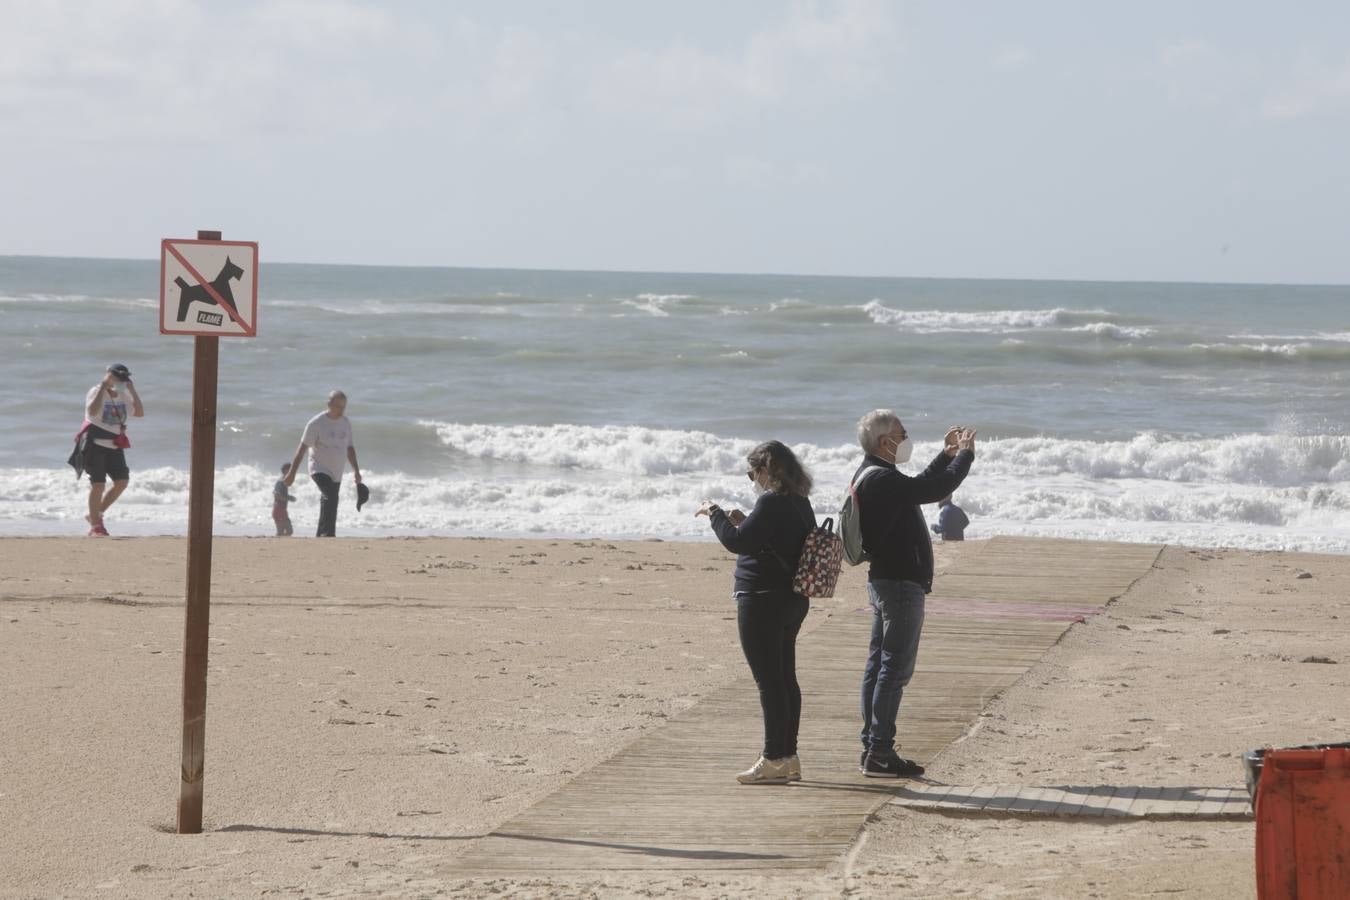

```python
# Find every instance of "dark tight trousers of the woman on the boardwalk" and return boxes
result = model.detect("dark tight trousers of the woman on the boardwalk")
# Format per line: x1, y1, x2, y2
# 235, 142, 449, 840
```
736, 591, 810, 760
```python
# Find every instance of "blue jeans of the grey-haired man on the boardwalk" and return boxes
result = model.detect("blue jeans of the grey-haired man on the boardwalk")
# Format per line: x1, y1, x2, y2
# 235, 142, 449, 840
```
860, 580, 923, 754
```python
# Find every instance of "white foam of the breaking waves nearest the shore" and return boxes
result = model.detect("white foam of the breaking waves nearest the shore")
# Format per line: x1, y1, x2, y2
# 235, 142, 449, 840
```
0, 421, 1350, 553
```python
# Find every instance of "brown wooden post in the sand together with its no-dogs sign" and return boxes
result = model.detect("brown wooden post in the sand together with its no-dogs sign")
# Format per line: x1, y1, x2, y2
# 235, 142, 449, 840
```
159, 231, 258, 834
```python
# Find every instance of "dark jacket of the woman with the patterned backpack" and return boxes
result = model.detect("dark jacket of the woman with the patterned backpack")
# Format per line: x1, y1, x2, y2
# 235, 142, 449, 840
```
711, 491, 815, 591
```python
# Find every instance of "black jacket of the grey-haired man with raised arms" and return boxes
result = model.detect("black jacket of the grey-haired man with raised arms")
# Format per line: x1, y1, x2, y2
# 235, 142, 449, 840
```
853, 451, 975, 591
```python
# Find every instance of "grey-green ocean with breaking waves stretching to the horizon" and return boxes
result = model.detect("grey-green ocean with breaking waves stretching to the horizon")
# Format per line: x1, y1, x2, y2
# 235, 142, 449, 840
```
0, 247, 1350, 553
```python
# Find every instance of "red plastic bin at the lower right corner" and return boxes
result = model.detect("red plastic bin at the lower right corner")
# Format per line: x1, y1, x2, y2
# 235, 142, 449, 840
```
1256, 746, 1350, 900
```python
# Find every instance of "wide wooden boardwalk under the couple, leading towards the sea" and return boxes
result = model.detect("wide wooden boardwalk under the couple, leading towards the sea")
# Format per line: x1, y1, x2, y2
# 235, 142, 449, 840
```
450, 538, 1161, 874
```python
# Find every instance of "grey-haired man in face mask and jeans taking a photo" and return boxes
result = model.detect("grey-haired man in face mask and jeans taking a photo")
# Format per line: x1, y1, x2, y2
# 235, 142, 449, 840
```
853, 409, 975, 779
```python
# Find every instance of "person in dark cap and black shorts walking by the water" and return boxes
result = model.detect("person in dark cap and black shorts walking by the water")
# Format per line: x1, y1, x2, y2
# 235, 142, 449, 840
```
82, 363, 146, 537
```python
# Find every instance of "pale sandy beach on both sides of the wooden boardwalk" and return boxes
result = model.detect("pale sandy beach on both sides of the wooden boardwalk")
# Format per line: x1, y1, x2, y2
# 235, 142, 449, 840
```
0, 538, 1350, 899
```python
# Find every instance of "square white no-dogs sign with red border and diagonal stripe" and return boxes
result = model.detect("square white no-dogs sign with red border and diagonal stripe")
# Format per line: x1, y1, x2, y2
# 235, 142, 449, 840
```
159, 237, 258, 337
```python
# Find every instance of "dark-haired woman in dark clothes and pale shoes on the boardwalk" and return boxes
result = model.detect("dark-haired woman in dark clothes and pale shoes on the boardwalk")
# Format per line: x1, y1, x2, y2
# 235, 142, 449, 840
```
694, 441, 815, 784
